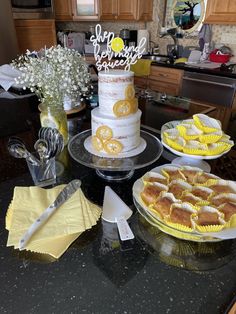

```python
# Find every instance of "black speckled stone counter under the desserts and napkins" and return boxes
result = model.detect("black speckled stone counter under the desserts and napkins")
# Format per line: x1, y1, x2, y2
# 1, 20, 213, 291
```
0, 124, 236, 314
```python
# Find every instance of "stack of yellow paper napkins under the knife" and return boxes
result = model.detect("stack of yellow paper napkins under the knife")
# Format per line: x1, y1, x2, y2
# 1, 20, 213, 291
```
6, 185, 101, 258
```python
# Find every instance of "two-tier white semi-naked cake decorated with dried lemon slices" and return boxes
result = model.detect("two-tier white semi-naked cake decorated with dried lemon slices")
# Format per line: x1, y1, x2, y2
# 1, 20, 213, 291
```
91, 70, 141, 155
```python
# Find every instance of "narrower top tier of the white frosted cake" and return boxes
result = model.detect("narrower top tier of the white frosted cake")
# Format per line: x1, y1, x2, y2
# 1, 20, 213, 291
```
98, 70, 134, 117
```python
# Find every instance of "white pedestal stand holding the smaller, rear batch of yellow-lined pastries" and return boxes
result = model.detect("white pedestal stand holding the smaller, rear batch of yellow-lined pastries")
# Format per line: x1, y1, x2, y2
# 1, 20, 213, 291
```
161, 121, 229, 172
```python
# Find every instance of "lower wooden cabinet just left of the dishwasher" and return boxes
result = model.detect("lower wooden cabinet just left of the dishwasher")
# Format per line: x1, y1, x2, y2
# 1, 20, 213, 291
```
148, 66, 183, 96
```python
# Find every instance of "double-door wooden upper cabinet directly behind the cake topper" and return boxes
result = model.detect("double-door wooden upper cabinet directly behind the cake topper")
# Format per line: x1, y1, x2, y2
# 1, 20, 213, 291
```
100, 0, 137, 20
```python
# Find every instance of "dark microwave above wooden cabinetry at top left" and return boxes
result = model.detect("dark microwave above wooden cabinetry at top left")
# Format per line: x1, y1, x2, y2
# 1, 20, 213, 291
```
11, 0, 54, 19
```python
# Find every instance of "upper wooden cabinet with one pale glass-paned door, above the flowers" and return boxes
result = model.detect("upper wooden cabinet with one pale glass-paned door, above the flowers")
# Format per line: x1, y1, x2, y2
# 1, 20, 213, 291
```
54, 0, 99, 21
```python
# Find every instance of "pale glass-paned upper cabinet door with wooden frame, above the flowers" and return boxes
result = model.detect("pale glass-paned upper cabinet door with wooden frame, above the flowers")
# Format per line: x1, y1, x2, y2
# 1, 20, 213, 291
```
71, 0, 99, 21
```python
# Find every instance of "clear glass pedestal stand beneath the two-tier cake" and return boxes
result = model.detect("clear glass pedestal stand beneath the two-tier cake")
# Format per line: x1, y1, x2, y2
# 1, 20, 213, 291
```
68, 129, 163, 181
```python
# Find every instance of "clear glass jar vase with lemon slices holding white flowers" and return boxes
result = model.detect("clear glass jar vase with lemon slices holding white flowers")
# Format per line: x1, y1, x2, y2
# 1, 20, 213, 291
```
39, 104, 69, 145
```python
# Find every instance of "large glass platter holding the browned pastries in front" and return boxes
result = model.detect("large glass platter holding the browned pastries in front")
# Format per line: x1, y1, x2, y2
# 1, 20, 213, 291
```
133, 164, 236, 242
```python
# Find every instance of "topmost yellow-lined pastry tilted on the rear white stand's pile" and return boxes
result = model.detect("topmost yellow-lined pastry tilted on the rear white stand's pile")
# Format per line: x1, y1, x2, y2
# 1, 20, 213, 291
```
193, 113, 221, 133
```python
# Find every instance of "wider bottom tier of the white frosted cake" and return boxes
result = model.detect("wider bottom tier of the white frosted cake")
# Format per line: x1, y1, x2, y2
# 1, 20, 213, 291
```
91, 108, 141, 153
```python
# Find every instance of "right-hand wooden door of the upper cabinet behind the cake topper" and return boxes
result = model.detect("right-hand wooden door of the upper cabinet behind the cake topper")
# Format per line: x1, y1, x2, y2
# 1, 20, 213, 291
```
117, 0, 137, 20
